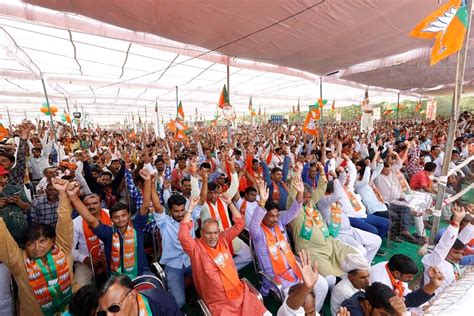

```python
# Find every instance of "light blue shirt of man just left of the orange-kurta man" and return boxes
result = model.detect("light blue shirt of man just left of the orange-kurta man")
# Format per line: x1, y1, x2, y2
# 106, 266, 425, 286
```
153, 205, 202, 269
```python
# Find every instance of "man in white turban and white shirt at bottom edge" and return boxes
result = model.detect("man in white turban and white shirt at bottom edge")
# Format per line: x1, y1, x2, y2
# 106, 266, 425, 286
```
331, 253, 370, 316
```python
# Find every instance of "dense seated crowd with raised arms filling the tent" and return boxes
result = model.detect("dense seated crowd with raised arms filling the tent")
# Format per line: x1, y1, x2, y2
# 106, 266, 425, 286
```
0, 112, 474, 316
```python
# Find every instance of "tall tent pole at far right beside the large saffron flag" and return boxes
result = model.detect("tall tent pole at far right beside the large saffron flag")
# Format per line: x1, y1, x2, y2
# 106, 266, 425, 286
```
430, 0, 472, 245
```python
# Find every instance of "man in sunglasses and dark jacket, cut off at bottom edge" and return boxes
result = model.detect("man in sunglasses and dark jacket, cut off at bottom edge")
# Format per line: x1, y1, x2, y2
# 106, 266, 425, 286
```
97, 275, 181, 316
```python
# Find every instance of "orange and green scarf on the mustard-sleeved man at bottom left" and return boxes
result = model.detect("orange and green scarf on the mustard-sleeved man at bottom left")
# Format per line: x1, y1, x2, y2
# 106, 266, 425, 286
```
25, 245, 72, 316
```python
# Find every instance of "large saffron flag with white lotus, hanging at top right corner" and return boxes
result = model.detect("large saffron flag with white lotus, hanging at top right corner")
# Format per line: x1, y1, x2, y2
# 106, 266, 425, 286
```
410, 0, 468, 66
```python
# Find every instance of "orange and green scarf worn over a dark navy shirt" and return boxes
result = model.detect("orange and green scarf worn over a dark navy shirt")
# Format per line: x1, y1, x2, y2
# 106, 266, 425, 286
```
110, 223, 138, 280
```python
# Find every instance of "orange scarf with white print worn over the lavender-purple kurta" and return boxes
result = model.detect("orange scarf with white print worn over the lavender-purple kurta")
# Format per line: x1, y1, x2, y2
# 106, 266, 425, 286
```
260, 223, 303, 284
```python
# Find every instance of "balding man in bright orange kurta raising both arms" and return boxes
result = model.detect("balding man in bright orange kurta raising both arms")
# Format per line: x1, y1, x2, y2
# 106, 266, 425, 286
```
178, 191, 269, 316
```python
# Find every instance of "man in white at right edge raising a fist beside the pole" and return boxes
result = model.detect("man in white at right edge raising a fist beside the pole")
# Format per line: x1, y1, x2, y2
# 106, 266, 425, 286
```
421, 205, 474, 294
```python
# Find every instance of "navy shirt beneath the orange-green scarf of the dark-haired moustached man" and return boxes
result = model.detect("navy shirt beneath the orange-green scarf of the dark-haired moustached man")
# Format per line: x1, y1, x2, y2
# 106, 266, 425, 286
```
93, 214, 149, 275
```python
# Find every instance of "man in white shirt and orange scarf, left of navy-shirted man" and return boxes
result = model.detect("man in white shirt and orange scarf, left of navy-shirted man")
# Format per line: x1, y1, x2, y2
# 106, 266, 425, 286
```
72, 193, 112, 286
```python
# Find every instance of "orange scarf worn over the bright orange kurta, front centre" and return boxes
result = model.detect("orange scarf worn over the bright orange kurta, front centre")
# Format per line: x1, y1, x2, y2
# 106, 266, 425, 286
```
199, 238, 245, 300
